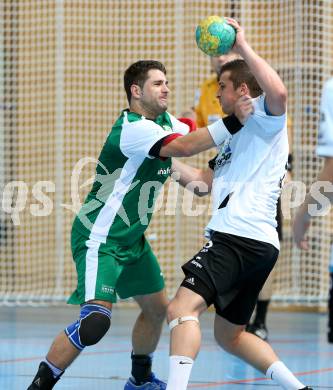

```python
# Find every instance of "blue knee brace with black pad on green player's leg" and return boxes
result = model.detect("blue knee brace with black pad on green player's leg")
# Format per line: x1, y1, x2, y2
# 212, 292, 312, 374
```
65, 304, 111, 351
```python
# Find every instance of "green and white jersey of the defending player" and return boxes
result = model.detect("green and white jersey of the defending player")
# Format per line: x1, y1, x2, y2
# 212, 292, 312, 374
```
73, 110, 189, 245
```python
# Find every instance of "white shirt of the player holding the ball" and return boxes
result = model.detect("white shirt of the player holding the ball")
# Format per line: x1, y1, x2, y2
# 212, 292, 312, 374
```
206, 95, 289, 249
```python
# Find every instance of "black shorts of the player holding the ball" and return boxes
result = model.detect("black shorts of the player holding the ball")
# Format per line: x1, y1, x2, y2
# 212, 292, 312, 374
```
181, 232, 279, 325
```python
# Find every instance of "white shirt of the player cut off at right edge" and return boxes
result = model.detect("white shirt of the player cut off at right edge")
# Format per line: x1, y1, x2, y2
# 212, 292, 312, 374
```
317, 78, 333, 157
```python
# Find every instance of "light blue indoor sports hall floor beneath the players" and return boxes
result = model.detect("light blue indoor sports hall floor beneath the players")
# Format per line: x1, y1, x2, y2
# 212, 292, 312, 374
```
0, 306, 333, 390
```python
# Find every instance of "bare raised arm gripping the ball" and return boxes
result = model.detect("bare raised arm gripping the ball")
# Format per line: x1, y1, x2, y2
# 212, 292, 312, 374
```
226, 18, 287, 115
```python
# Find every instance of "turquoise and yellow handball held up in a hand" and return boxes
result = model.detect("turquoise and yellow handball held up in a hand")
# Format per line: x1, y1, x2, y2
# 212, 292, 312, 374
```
195, 15, 236, 57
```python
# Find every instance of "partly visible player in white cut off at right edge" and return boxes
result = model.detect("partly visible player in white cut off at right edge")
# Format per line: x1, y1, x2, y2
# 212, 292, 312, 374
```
293, 78, 333, 343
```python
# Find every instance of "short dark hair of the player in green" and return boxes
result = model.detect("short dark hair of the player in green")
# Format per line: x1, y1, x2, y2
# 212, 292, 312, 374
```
124, 60, 166, 103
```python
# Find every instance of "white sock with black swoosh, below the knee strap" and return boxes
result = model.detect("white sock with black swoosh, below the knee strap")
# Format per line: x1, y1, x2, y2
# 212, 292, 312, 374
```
166, 355, 194, 390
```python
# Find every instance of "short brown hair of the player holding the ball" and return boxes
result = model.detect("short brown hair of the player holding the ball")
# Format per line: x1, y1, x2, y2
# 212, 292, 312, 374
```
219, 59, 263, 97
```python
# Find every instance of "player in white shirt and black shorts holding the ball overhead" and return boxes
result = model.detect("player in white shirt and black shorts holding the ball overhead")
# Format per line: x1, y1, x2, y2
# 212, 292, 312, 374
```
162, 18, 308, 390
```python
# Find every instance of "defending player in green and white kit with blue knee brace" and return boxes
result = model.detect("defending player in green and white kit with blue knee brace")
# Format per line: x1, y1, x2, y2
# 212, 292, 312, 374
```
28, 61, 251, 390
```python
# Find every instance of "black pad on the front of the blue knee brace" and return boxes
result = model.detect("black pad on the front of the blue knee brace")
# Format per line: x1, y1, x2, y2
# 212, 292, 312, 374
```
79, 312, 111, 346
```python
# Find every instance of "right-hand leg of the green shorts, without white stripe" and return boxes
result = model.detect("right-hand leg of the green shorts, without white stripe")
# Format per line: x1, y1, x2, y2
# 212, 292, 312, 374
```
116, 240, 164, 298
